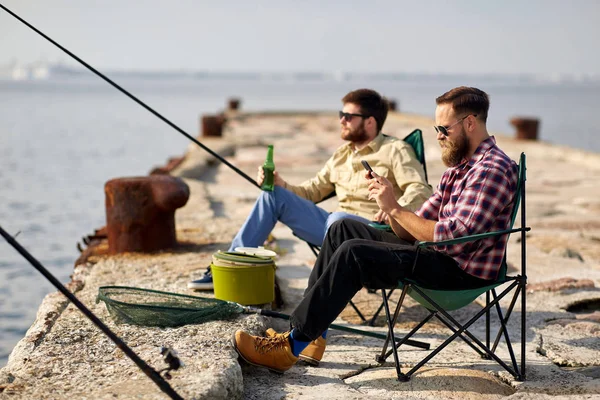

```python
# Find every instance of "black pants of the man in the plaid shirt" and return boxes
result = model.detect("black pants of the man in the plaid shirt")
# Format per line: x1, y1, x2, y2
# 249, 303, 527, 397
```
290, 219, 490, 340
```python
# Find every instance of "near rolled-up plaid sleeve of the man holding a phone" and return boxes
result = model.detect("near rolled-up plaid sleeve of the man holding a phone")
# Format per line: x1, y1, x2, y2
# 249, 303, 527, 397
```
433, 168, 512, 253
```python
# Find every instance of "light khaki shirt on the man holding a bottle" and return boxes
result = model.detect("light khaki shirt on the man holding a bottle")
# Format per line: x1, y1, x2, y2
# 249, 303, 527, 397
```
285, 133, 433, 220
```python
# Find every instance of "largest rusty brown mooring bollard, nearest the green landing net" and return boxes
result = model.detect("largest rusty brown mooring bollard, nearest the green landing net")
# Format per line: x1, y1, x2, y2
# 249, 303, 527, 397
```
104, 175, 190, 254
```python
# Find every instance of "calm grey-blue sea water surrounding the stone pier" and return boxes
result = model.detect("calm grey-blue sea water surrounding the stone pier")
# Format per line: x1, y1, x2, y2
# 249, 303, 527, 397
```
0, 76, 600, 367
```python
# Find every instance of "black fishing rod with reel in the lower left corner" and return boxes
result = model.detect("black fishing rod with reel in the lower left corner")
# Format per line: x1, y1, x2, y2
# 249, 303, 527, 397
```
0, 225, 183, 400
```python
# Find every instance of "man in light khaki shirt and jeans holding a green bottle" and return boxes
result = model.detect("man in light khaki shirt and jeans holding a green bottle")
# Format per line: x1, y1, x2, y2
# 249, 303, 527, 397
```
188, 89, 432, 290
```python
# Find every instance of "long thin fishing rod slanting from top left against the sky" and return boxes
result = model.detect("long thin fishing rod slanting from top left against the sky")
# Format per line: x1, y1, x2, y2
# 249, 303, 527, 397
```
0, 3, 260, 189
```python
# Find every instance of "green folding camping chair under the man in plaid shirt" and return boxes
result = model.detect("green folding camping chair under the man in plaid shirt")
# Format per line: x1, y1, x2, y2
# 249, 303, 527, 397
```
376, 153, 531, 381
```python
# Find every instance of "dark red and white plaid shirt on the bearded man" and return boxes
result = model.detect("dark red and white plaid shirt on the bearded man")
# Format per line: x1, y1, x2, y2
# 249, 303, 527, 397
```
416, 136, 518, 279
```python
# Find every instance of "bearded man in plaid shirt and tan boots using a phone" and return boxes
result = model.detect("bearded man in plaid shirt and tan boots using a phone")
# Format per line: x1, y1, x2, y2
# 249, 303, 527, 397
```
233, 87, 518, 372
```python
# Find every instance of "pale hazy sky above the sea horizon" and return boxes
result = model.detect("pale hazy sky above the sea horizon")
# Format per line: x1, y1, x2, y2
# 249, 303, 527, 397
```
0, 0, 600, 76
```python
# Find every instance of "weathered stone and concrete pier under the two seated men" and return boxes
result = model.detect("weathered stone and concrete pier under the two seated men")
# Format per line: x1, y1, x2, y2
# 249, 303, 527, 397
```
0, 110, 600, 400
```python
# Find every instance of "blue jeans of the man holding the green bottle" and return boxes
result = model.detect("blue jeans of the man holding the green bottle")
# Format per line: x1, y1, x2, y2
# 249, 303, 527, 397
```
229, 186, 370, 251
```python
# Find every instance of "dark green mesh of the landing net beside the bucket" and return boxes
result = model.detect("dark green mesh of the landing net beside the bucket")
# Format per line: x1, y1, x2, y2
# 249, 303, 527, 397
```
96, 286, 244, 328
